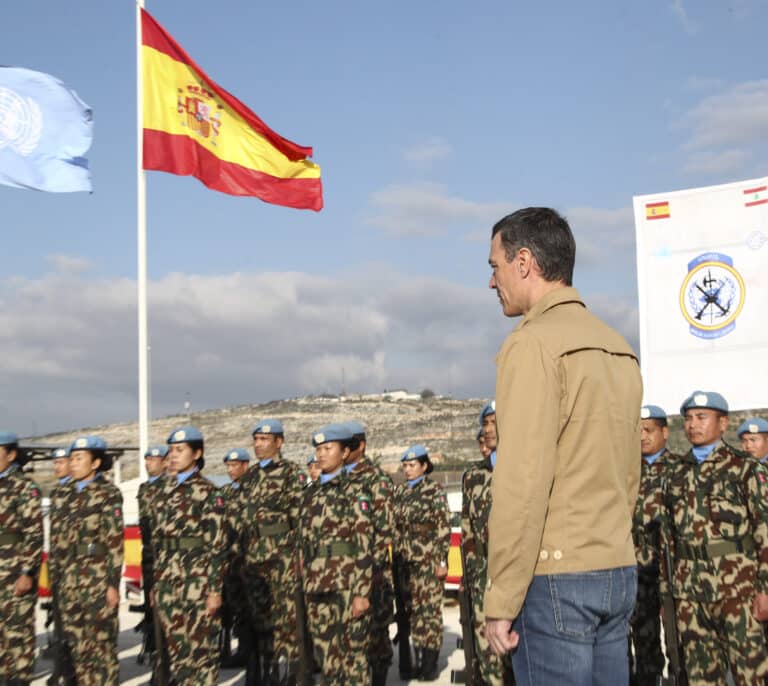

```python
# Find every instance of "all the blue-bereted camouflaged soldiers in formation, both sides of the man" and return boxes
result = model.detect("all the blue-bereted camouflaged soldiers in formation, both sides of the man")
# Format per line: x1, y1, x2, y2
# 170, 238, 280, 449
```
0, 391, 768, 686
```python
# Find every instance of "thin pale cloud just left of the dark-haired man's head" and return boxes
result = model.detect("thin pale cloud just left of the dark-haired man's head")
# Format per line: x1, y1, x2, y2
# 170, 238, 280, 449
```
366, 183, 510, 236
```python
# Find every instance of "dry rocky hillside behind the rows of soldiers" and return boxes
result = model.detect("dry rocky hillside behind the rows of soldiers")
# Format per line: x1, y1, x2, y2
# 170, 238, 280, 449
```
22, 391, 766, 490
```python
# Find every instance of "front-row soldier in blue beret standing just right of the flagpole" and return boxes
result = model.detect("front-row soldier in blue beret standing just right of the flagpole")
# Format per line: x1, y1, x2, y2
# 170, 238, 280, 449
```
152, 426, 225, 686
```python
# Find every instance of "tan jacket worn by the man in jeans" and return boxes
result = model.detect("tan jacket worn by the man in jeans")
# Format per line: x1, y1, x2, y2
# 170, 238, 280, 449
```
485, 287, 642, 619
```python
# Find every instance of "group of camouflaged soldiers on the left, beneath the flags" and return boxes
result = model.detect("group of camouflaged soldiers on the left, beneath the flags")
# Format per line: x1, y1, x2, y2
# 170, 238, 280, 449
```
0, 419, 450, 686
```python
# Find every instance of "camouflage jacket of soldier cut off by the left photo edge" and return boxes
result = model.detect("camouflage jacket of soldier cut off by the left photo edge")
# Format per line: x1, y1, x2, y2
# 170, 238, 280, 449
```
0, 466, 43, 586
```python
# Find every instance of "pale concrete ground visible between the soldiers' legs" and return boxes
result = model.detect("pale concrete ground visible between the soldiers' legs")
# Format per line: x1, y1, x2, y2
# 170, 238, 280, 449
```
32, 599, 464, 686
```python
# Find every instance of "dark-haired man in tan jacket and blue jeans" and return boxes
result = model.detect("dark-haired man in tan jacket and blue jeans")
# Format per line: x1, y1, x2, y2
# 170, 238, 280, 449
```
485, 207, 642, 686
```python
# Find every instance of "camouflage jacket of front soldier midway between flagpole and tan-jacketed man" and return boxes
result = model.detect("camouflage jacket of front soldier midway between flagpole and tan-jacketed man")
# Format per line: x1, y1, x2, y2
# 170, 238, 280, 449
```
299, 470, 374, 597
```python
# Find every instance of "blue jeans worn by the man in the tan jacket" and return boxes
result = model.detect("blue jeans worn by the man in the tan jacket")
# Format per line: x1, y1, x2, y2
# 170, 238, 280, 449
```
512, 566, 637, 686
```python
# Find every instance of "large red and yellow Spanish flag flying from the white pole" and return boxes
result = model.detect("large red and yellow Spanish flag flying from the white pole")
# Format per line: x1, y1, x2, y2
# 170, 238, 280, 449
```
141, 9, 323, 210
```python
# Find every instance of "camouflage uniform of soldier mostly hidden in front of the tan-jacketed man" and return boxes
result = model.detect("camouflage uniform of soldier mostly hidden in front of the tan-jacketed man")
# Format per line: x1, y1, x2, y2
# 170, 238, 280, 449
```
461, 459, 512, 686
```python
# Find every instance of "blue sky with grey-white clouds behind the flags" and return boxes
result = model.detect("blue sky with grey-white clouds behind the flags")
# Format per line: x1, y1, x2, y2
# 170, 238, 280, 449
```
0, 0, 768, 433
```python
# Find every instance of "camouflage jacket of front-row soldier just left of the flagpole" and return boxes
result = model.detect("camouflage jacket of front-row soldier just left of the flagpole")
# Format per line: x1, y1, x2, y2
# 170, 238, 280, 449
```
51, 474, 123, 588
